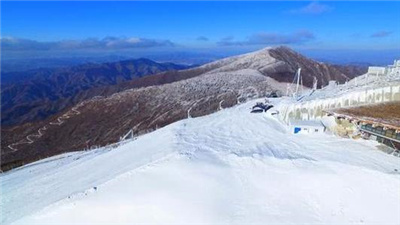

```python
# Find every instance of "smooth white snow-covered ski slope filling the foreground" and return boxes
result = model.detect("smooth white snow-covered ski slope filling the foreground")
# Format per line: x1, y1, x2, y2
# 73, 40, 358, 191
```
0, 99, 400, 225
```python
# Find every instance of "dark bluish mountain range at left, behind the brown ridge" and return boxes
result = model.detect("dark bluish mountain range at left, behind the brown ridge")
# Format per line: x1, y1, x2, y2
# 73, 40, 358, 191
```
1, 59, 189, 125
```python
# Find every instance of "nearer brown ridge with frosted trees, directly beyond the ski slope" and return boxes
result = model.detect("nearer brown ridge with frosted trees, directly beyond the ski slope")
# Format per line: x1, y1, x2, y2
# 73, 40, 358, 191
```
1, 69, 286, 171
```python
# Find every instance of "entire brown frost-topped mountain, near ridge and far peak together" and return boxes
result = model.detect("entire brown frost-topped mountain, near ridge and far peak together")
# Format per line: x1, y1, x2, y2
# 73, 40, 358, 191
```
1, 47, 368, 169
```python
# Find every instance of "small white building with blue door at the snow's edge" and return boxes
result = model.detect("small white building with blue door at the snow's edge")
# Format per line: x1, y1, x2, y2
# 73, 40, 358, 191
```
289, 120, 325, 134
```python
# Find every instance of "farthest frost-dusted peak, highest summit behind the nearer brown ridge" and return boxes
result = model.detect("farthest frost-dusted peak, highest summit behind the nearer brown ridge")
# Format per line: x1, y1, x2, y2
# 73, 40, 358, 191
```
199, 46, 366, 87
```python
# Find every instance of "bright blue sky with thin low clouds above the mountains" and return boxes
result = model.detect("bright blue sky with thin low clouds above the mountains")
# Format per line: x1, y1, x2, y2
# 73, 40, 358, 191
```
1, 1, 400, 63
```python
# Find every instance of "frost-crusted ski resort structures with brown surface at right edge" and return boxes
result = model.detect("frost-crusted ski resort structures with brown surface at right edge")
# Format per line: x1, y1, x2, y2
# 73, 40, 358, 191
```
279, 60, 400, 155
